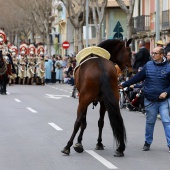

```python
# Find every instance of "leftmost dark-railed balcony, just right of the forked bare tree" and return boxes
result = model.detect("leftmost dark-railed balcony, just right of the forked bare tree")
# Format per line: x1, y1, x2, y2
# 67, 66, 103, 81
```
132, 15, 150, 34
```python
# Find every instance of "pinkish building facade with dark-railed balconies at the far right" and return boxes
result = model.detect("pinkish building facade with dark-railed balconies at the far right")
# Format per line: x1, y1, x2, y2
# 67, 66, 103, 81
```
132, 0, 170, 51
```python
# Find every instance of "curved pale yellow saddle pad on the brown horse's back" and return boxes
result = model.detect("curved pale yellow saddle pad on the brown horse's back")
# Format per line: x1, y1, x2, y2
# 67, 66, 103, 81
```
76, 46, 110, 64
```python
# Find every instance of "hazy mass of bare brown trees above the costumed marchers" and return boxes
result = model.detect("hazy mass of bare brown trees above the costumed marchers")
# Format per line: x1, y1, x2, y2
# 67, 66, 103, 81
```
0, 0, 52, 54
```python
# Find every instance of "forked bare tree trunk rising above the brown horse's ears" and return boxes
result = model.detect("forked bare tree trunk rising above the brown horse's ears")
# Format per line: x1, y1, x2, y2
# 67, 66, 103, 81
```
116, 0, 135, 39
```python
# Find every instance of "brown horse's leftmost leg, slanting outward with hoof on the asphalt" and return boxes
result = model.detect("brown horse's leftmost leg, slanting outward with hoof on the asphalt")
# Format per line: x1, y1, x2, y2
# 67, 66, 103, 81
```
61, 104, 87, 155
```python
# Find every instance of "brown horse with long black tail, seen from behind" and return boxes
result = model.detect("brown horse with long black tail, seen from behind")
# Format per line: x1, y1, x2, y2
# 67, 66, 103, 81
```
61, 39, 131, 157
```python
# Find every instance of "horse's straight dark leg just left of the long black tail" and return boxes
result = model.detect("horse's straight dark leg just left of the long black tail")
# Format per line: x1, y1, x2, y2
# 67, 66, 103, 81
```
95, 102, 106, 150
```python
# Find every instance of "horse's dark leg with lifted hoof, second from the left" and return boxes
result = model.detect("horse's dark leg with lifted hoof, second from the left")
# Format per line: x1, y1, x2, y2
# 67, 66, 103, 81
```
74, 109, 87, 153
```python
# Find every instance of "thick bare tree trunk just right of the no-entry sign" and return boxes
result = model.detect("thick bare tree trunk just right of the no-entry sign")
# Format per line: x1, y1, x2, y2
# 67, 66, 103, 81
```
61, 0, 86, 53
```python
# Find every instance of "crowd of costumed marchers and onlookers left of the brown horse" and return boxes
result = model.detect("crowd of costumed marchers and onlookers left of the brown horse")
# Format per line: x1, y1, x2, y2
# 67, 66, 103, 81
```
0, 30, 76, 95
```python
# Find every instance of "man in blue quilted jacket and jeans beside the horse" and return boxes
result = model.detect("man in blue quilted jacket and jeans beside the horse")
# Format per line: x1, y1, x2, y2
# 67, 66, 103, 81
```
119, 47, 170, 152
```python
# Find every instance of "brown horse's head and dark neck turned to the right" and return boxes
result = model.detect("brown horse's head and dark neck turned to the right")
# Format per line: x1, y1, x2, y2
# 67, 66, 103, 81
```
98, 39, 132, 74
